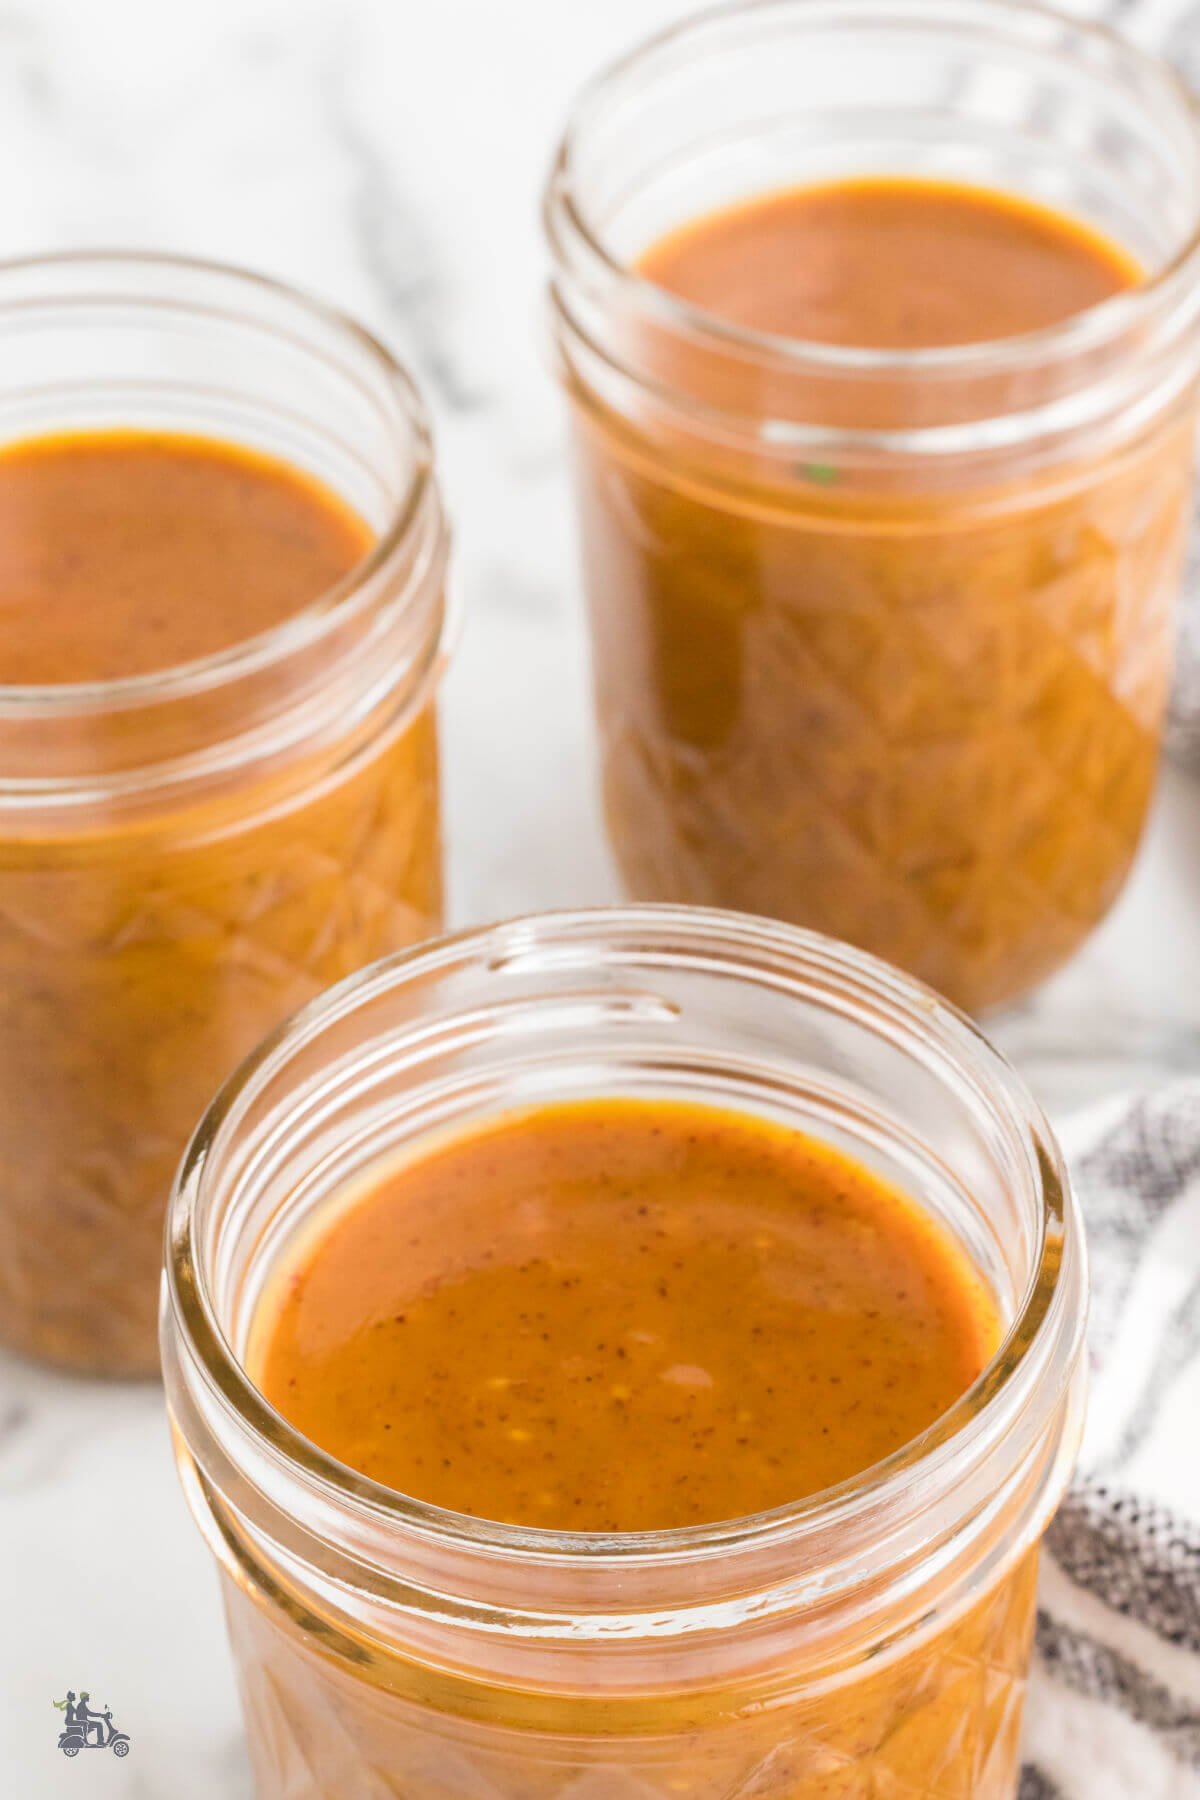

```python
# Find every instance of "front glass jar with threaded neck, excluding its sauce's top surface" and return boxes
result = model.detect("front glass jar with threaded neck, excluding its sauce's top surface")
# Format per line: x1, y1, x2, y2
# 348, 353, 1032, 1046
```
162, 907, 1085, 1800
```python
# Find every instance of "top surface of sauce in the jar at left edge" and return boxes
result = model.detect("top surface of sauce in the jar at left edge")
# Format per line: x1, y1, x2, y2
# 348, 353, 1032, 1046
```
0, 430, 372, 684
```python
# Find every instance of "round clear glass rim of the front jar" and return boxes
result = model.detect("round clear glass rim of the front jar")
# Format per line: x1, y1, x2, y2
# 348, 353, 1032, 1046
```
164, 905, 1085, 1566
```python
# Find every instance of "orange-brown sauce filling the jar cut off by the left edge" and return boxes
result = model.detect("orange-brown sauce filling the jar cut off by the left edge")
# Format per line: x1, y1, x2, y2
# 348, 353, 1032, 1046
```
0, 430, 441, 1375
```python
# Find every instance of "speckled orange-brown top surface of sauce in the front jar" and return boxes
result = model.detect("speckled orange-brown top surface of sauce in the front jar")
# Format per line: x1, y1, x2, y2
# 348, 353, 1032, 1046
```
246, 1100, 999, 1532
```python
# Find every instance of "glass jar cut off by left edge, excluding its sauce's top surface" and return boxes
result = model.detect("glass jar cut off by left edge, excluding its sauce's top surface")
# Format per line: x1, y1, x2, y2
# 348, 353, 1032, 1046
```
0, 256, 446, 1375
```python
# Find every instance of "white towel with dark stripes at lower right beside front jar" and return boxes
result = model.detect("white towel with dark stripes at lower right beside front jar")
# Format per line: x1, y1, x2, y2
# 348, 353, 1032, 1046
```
1020, 1082, 1200, 1800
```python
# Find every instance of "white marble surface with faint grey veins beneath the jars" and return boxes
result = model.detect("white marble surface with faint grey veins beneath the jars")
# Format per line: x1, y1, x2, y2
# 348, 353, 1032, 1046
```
0, 0, 1200, 1800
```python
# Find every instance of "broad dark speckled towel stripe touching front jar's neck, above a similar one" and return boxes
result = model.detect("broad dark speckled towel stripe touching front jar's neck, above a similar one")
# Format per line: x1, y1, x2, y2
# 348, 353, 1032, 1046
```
1047, 1483, 1200, 1656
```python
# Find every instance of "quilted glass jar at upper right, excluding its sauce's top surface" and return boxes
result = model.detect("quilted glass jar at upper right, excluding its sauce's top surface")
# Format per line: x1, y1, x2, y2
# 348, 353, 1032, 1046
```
545, 0, 1200, 1010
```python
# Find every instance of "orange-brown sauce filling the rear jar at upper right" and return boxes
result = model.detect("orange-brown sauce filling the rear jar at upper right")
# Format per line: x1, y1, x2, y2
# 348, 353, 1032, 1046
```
570, 178, 1195, 1010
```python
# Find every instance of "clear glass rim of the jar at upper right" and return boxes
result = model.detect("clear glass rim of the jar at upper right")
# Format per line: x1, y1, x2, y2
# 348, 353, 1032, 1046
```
543, 0, 1200, 376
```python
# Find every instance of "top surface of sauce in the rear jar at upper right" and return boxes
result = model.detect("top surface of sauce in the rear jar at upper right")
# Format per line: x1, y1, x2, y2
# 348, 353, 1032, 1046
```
639, 176, 1141, 349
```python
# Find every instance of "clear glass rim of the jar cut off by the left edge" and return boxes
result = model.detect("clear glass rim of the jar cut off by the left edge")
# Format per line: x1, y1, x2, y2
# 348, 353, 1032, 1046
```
0, 248, 434, 720
